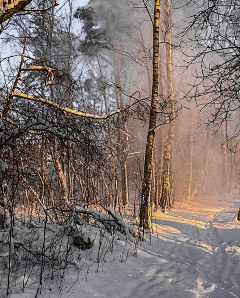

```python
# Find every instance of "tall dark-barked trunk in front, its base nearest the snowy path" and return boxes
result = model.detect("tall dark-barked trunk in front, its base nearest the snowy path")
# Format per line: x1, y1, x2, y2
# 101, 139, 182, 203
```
140, 0, 161, 229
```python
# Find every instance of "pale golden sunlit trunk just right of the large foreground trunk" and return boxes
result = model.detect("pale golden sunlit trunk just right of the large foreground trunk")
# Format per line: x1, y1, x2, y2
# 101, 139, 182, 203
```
160, 0, 175, 210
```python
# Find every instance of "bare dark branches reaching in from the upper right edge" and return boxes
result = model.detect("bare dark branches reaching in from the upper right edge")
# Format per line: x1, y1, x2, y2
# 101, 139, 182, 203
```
185, 0, 240, 147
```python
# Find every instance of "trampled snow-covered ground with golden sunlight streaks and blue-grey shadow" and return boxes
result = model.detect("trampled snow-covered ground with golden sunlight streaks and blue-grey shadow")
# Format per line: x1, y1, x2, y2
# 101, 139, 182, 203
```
1, 193, 240, 298
